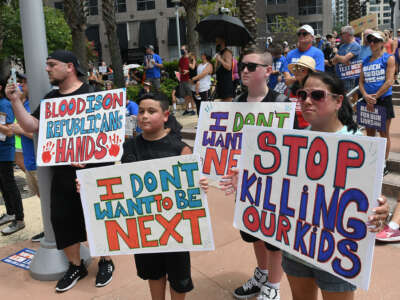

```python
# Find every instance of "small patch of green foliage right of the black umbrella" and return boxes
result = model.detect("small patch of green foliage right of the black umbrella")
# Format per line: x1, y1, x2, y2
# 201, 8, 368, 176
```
270, 15, 299, 45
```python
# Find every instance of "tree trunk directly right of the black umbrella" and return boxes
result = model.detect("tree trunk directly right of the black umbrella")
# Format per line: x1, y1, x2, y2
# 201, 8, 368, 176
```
237, 0, 257, 51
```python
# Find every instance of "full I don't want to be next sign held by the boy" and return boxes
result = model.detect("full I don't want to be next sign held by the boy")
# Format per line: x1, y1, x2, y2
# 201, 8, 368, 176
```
76, 155, 214, 256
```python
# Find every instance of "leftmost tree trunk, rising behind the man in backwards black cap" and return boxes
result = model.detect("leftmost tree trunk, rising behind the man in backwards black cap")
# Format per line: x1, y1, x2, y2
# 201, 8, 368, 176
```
64, 0, 88, 70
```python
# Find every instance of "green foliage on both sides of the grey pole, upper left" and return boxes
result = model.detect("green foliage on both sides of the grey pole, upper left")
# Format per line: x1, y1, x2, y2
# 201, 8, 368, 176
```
0, 4, 72, 60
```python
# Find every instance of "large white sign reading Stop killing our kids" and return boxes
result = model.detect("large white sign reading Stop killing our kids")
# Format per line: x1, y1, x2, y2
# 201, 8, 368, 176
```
234, 126, 386, 290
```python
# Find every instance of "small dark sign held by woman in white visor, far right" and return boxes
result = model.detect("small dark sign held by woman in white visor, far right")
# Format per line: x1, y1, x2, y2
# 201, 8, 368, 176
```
357, 101, 386, 131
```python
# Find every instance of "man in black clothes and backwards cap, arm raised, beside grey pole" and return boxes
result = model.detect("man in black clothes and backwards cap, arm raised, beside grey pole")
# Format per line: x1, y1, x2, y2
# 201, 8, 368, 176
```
6, 50, 114, 292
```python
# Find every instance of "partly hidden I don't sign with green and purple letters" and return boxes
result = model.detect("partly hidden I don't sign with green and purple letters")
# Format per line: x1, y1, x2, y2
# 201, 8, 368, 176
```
194, 102, 296, 180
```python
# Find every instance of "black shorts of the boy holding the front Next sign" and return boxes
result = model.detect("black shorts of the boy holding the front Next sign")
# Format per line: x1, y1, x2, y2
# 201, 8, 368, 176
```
135, 252, 193, 293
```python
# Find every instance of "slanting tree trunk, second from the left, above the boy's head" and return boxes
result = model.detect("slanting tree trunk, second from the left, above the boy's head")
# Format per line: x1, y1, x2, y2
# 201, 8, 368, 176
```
102, 0, 125, 88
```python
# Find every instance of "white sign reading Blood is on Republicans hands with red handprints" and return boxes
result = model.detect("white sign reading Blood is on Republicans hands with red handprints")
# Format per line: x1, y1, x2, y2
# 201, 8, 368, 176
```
36, 89, 126, 167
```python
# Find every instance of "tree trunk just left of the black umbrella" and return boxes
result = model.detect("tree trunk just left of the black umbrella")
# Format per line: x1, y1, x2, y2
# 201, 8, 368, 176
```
181, 0, 200, 57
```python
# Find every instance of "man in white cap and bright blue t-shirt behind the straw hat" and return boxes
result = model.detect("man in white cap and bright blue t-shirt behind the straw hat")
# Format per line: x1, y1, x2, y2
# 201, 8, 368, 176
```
284, 24, 325, 86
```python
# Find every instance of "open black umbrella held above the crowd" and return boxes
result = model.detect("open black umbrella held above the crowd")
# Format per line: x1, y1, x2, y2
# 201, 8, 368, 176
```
195, 14, 252, 46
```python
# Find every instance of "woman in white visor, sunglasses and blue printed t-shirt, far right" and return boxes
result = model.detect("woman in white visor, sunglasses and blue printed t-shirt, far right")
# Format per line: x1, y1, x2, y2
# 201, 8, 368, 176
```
359, 31, 395, 175
